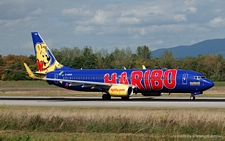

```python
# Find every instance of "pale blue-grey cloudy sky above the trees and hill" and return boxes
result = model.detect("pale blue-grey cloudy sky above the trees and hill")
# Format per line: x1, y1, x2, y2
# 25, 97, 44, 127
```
0, 0, 225, 56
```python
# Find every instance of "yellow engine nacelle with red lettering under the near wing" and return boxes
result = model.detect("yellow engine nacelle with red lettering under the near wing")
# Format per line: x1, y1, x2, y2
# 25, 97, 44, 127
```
108, 85, 133, 97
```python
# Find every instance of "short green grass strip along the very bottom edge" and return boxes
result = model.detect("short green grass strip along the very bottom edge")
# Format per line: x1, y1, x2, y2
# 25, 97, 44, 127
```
0, 131, 223, 141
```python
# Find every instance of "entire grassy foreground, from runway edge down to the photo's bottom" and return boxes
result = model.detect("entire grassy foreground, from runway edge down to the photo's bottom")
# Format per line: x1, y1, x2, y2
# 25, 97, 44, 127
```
0, 105, 225, 141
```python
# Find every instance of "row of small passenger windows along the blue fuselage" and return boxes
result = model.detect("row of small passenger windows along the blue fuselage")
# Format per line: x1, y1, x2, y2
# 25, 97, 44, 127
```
63, 76, 175, 80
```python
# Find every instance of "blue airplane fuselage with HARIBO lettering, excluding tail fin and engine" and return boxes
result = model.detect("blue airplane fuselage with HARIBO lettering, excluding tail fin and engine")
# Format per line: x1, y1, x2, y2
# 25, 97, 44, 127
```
46, 69, 214, 94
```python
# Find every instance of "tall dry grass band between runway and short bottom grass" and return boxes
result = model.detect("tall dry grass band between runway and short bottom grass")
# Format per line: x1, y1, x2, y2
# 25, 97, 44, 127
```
0, 105, 225, 136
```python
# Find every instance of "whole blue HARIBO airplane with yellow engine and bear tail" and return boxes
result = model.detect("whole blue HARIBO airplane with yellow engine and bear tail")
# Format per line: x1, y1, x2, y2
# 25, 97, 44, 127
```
24, 32, 214, 100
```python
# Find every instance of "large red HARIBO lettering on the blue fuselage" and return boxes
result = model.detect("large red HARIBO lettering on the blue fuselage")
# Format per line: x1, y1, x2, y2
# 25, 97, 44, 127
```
104, 69, 177, 91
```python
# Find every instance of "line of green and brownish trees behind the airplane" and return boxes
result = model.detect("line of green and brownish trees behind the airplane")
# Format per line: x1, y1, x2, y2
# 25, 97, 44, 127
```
0, 46, 225, 81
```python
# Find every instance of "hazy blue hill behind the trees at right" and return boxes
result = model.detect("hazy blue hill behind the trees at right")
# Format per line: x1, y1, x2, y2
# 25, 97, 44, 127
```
152, 39, 225, 58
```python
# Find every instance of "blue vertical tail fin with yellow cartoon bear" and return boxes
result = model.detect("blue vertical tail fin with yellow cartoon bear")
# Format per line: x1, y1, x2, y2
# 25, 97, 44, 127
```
31, 32, 63, 73
